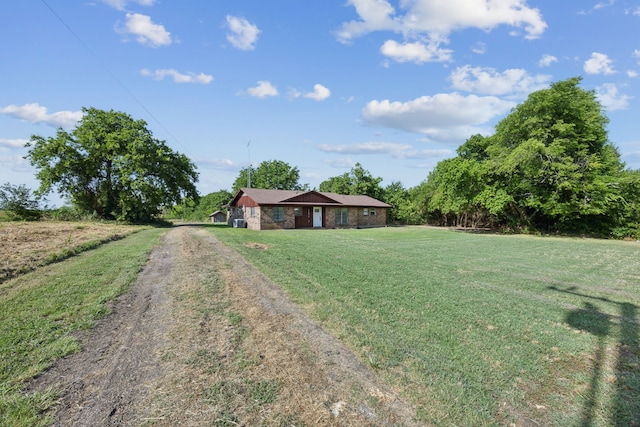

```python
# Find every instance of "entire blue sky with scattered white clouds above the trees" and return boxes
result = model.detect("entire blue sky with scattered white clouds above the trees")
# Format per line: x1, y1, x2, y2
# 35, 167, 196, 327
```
0, 0, 640, 203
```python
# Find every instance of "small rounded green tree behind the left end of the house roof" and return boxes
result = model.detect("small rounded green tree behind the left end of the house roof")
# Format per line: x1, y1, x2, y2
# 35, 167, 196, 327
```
232, 160, 308, 193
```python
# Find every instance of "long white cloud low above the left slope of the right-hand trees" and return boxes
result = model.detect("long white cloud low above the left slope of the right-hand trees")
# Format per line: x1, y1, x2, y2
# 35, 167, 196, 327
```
362, 92, 515, 140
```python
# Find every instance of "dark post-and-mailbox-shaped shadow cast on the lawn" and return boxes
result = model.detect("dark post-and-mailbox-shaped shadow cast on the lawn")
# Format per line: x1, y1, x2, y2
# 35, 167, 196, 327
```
549, 286, 640, 427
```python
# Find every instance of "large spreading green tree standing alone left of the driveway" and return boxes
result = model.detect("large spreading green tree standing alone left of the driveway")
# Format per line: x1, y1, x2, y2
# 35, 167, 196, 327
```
27, 108, 198, 222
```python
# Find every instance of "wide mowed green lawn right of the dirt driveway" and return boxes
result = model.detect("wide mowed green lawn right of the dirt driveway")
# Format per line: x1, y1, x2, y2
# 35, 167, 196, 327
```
213, 227, 640, 426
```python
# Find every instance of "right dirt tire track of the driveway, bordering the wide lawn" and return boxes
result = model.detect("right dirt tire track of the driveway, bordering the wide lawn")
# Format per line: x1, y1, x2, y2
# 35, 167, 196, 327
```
211, 231, 417, 426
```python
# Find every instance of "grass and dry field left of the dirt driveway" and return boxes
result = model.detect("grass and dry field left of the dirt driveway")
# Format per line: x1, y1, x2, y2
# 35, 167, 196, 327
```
0, 223, 162, 426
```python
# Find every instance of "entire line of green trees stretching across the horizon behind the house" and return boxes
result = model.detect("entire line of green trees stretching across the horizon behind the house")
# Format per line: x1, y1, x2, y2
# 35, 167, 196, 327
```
0, 77, 640, 238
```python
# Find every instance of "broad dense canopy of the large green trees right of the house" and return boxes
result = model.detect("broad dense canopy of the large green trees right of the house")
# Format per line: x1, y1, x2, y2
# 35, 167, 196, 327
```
427, 77, 632, 234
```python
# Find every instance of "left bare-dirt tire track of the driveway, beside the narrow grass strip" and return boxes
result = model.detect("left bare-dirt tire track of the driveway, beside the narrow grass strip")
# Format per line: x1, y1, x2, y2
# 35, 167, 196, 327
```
32, 233, 177, 427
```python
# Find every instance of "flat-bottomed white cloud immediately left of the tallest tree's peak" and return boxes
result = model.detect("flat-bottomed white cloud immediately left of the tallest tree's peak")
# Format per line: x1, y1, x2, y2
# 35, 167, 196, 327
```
449, 65, 551, 95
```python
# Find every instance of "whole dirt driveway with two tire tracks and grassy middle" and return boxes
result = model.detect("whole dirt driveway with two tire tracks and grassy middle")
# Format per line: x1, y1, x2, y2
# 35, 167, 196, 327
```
32, 226, 418, 426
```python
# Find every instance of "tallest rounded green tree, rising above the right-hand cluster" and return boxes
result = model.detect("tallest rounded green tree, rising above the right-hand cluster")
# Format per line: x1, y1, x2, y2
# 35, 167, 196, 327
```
489, 78, 623, 228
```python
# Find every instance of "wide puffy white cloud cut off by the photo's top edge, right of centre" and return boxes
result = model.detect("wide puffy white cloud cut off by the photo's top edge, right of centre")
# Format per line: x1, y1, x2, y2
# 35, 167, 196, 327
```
337, 0, 547, 42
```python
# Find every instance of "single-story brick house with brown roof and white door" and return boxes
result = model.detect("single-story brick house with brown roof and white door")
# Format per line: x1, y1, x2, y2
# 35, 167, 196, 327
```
228, 188, 391, 230
